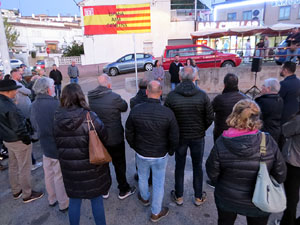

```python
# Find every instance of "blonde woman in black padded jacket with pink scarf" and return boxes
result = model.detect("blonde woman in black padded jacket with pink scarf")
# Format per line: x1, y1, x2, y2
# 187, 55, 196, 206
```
206, 99, 286, 225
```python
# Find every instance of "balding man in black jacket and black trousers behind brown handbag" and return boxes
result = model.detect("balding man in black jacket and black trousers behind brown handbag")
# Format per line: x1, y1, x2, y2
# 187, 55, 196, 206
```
88, 74, 136, 199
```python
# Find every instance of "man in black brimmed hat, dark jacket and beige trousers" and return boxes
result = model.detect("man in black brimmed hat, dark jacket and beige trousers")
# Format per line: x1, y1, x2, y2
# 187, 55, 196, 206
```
0, 80, 44, 203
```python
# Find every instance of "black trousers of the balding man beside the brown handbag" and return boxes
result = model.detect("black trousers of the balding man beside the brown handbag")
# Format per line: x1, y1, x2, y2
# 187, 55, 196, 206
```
106, 141, 130, 192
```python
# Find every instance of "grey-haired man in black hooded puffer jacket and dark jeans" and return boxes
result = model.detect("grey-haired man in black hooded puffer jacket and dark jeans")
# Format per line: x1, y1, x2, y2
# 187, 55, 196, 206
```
165, 66, 214, 206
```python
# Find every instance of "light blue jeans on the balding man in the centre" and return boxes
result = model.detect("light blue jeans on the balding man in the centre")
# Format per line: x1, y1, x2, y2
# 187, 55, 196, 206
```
136, 155, 168, 215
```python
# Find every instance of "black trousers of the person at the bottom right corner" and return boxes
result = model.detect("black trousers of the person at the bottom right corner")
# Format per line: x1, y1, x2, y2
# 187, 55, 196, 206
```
280, 163, 300, 225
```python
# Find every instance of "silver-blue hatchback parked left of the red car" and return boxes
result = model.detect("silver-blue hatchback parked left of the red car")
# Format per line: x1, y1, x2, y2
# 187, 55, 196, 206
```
103, 53, 155, 76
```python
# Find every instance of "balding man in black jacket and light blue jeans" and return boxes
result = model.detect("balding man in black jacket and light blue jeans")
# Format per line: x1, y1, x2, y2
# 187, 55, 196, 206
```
126, 81, 179, 222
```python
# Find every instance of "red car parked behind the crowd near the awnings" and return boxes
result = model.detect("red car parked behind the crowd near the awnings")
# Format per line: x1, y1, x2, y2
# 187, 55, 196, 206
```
163, 45, 242, 70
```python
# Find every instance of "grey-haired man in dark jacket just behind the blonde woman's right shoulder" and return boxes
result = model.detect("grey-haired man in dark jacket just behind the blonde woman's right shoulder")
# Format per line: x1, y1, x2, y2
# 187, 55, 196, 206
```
255, 78, 283, 143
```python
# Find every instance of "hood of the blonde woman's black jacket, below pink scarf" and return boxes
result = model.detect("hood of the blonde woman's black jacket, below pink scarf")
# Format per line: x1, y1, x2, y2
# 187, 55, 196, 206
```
222, 132, 261, 157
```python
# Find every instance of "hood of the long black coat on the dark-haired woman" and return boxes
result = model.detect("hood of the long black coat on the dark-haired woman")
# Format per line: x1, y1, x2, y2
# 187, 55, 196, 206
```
54, 107, 86, 131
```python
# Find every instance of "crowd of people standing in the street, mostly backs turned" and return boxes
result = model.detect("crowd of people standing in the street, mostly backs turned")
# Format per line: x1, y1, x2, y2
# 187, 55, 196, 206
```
0, 56, 300, 225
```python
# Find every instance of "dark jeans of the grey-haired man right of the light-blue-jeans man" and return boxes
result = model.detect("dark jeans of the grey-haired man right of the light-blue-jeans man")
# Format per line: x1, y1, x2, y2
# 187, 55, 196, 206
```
175, 138, 205, 198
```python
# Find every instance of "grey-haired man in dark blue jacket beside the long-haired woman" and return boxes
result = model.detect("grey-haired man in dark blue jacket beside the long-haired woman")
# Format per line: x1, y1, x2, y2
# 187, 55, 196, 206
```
30, 77, 69, 212
